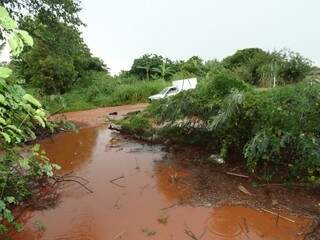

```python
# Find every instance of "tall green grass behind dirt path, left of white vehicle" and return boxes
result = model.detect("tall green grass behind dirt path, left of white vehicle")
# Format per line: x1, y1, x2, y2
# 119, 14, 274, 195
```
35, 71, 168, 113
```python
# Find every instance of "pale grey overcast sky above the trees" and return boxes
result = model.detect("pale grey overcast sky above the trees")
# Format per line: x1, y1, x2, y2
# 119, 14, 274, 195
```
80, 0, 320, 73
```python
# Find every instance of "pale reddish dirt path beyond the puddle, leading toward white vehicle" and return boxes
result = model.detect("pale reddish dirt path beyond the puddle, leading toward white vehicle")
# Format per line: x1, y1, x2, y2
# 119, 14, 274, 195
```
51, 103, 148, 127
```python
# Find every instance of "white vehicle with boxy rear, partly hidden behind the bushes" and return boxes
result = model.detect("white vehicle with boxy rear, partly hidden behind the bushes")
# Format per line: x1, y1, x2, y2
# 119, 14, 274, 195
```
149, 78, 197, 101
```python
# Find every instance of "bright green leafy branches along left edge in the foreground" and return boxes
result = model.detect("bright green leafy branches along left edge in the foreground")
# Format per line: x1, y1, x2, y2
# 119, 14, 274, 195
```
0, 7, 56, 234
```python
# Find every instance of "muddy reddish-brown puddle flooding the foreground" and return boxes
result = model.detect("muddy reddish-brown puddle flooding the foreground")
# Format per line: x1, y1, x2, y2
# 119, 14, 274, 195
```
13, 127, 309, 240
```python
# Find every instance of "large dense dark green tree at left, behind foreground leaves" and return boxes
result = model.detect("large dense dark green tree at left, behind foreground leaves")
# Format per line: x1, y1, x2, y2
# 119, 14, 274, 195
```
14, 17, 107, 94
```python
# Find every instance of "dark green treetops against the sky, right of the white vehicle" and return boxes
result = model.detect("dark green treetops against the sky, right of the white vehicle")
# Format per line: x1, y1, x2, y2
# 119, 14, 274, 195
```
222, 48, 311, 87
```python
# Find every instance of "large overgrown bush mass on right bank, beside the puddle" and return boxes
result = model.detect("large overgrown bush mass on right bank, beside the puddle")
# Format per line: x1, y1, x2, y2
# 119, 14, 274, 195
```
121, 71, 320, 184
